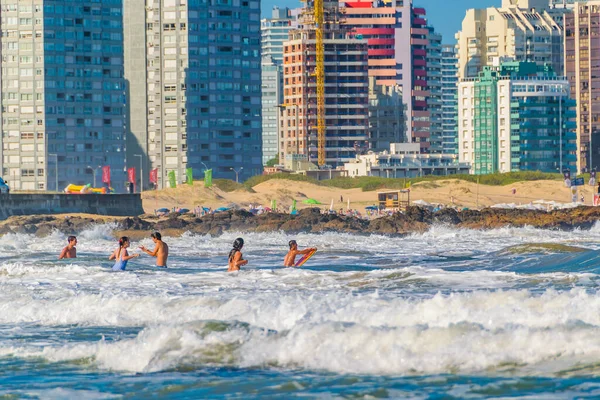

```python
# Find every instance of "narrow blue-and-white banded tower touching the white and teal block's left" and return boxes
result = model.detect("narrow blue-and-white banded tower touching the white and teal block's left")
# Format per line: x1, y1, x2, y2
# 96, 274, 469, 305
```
441, 44, 458, 154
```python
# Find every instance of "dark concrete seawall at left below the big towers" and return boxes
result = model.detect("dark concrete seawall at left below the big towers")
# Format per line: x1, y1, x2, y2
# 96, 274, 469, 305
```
0, 194, 144, 220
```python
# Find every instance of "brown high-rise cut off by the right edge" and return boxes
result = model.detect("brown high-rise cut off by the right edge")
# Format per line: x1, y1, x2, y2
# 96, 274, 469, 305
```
565, 0, 600, 172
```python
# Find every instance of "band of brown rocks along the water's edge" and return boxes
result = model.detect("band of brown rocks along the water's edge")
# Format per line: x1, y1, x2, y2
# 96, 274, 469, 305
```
0, 206, 600, 238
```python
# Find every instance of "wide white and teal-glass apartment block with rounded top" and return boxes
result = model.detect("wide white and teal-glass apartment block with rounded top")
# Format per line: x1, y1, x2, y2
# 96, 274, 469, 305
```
458, 62, 576, 174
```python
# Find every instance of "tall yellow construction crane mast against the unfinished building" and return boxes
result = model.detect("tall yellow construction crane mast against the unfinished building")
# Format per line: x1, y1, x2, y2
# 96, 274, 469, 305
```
313, 0, 325, 166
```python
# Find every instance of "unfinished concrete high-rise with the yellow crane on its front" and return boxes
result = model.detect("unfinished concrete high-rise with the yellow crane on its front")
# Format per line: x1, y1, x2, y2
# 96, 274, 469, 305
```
279, 0, 369, 167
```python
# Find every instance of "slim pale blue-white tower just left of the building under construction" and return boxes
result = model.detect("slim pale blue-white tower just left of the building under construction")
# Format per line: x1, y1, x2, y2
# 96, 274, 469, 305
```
260, 7, 293, 164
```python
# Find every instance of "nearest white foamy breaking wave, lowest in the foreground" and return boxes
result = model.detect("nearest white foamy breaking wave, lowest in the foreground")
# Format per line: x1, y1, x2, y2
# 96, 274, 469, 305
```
0, 312, 600, 375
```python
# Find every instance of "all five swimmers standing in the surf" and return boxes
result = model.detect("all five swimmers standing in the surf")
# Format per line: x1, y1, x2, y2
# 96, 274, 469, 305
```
58, 232, 317, 272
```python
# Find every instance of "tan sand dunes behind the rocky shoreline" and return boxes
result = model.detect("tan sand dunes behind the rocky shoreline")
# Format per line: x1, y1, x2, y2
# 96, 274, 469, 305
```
142, 179, 595, 212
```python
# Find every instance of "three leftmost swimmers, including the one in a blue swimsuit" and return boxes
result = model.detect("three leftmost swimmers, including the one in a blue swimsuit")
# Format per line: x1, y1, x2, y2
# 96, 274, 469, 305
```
58, 232, 169, 271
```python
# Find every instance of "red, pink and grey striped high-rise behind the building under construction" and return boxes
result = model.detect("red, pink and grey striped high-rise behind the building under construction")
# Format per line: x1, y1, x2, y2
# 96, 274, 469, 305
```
340, 0, 431, 152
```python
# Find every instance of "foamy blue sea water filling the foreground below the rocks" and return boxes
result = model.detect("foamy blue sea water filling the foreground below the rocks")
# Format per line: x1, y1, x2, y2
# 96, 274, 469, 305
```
0, 225, 600, 399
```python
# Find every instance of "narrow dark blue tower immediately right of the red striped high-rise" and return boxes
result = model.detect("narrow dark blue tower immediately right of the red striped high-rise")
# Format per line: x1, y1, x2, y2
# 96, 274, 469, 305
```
427, 27, 444, 154
